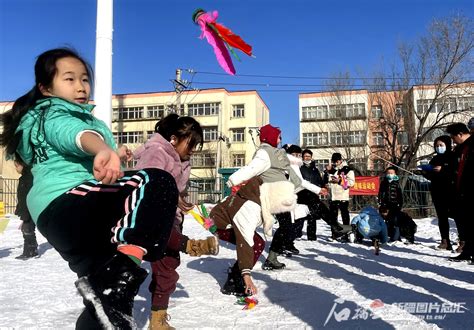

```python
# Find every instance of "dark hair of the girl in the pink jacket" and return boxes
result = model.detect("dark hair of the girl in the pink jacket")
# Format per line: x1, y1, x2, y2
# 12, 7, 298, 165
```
155, 113, 204, 149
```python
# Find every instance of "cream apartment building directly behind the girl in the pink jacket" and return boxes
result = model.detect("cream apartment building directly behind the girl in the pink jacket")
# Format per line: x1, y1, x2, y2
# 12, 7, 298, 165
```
0, 88, 269, 186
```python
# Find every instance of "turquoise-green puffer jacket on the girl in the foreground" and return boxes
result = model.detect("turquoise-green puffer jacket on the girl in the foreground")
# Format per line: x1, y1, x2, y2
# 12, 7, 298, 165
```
16, 97, 116, 223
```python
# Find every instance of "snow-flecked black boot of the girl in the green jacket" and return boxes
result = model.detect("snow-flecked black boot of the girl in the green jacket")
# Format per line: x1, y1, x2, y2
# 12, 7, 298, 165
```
75, 253, 148, 329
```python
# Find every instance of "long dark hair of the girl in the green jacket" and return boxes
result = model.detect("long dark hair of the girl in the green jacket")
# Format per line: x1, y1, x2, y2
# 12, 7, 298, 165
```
0, 48, 93, 157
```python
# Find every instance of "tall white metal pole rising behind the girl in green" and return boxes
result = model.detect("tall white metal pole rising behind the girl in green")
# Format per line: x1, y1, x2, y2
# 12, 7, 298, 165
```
94, 0, 113, 128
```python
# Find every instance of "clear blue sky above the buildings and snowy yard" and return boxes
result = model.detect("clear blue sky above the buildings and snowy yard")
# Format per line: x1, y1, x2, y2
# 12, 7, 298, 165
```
0, 0, 474, 143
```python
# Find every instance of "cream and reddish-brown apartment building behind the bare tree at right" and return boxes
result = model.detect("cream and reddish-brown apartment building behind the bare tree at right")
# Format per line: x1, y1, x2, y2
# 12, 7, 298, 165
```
299, 82, 474, 173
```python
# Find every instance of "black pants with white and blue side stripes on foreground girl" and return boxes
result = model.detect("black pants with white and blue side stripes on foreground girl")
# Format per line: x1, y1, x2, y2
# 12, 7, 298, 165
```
38, 169, 178, 277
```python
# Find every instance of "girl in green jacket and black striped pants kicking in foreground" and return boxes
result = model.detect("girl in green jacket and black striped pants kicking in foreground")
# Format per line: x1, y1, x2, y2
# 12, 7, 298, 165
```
0, 48, 178, 329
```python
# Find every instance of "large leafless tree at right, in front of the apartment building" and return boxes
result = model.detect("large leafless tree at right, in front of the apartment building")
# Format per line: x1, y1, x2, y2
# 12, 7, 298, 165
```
370, 16, 474, 168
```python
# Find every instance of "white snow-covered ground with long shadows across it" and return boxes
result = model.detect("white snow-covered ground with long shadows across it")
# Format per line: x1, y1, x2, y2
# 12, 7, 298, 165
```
0, 213, 474, 330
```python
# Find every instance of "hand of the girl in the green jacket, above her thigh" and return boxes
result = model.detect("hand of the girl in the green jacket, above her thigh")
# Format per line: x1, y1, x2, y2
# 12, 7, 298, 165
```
93, 149, 123, 184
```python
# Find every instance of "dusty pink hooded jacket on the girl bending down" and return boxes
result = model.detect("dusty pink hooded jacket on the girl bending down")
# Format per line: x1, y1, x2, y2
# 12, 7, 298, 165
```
133, 133, 191, 193
